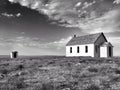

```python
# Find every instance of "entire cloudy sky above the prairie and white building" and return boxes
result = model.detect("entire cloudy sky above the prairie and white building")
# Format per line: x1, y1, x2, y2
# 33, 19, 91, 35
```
0, 0, 120, 56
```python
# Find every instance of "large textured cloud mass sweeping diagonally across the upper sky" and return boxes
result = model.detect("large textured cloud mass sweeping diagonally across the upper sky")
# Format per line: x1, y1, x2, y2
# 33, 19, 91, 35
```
9, 0, 120, 33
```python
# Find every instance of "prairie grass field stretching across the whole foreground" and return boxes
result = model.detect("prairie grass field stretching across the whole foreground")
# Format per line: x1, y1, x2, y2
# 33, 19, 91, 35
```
0, 56, 120, 90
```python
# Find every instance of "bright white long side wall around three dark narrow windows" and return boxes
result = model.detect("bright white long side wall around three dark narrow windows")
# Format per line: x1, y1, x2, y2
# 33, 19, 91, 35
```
66, 44, 94, 57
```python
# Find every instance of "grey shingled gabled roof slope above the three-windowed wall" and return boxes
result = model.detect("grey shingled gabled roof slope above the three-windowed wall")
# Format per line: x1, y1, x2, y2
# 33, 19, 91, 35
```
66, 33, 106, 46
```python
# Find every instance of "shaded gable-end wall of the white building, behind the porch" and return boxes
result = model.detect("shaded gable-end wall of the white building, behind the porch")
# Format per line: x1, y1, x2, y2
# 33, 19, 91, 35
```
94, 34, 107, 57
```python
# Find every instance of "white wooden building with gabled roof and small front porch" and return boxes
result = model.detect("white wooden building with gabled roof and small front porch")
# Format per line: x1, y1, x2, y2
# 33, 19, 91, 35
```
66, 33, 113, 57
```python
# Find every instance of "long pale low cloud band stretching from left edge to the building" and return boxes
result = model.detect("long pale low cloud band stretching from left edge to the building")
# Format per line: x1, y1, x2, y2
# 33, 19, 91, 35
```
0, 36, 72, 50
